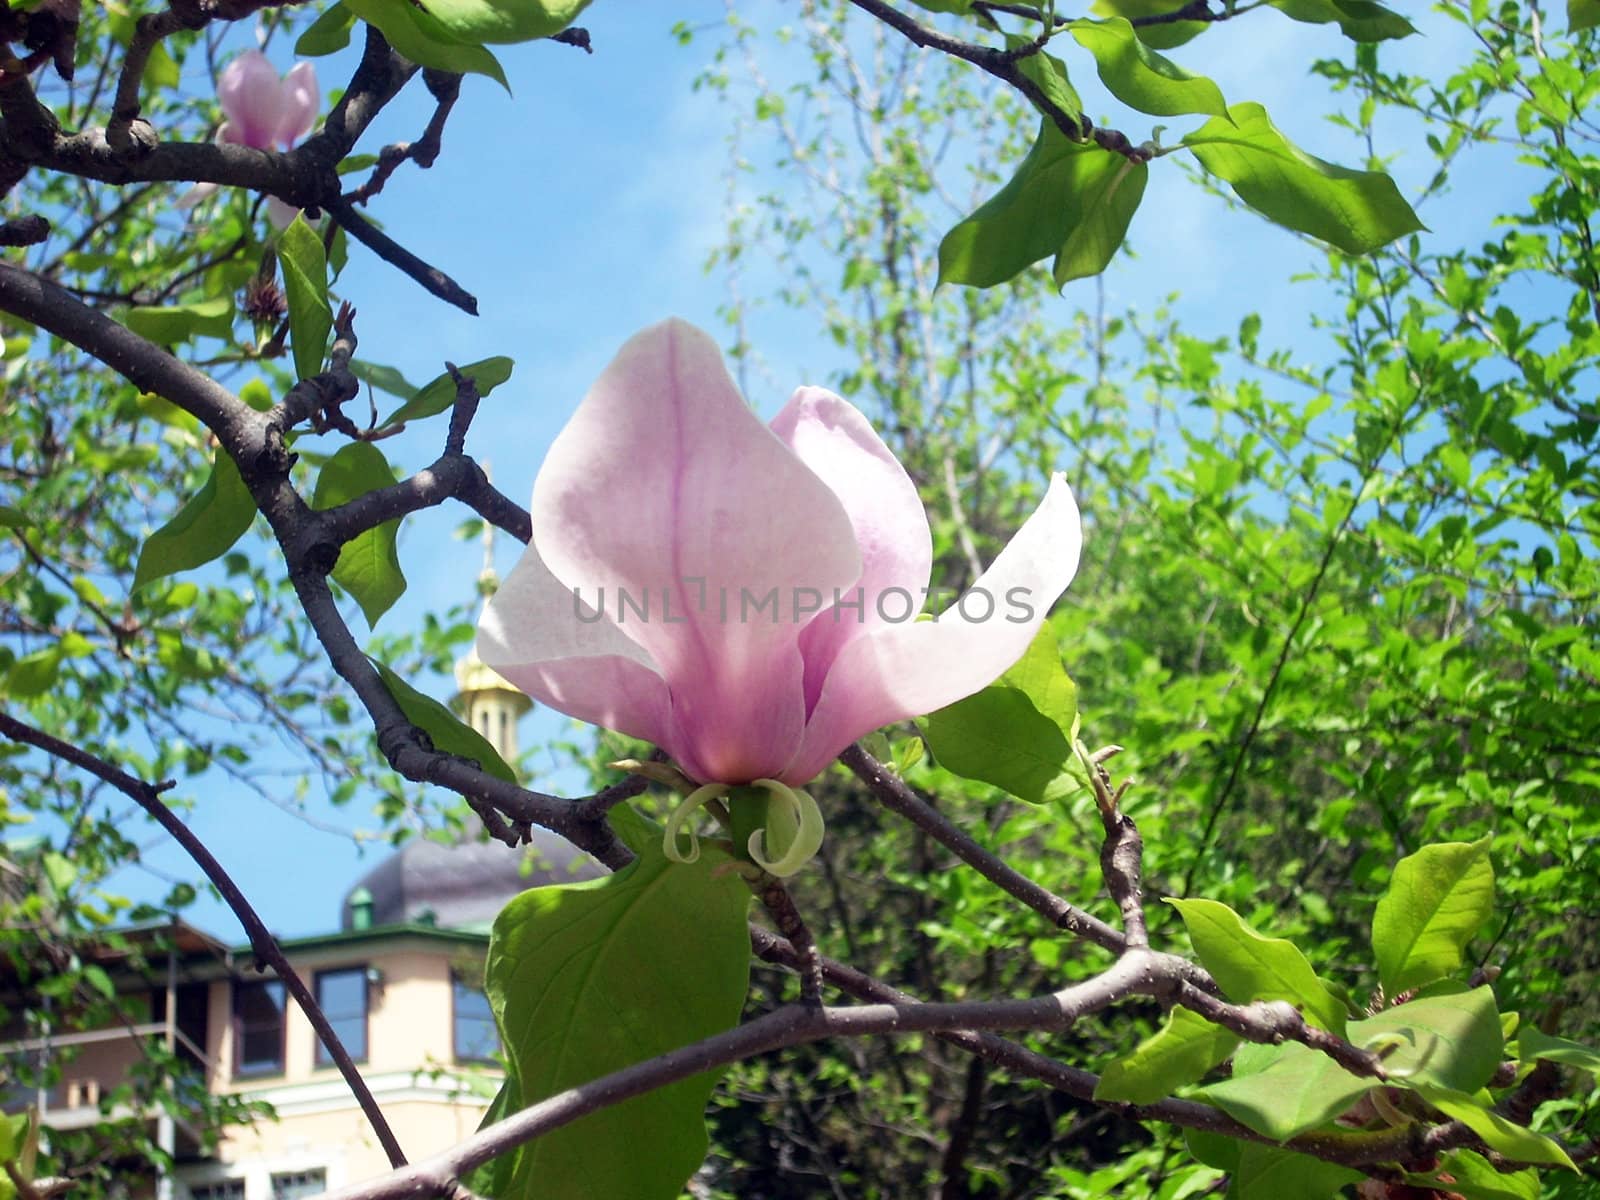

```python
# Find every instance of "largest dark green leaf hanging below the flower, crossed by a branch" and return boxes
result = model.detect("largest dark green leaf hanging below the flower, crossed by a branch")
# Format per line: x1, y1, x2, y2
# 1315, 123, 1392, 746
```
486, 806, 750, 1200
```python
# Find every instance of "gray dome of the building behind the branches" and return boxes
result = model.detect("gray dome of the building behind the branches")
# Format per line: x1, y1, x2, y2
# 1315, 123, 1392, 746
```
339, 829, 605, 930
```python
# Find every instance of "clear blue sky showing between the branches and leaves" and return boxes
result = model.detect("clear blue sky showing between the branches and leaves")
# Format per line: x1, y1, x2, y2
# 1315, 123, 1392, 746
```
118, 0, 1528, 938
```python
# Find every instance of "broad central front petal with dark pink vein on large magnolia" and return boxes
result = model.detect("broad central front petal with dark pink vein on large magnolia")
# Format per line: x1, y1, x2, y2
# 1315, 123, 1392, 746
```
531, 320, 861, 782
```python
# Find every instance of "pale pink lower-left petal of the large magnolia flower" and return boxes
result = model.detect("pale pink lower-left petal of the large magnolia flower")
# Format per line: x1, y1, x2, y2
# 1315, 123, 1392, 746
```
478, 534, 688, 771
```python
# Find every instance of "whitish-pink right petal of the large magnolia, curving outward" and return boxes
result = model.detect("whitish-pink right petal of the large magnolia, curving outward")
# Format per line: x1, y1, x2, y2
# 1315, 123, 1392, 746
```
779, 475, 1083, 784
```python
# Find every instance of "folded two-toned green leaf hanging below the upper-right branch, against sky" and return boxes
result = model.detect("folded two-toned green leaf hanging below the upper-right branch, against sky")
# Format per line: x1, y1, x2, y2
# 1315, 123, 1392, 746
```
939, 122, 1150, 288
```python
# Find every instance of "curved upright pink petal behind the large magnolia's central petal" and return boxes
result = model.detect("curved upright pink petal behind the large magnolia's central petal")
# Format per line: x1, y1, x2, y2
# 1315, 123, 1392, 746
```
773, 387, 933, 712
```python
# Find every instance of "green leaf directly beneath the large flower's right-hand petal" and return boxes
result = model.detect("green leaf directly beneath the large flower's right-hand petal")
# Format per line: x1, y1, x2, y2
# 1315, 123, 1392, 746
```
925, 624, 1080, 805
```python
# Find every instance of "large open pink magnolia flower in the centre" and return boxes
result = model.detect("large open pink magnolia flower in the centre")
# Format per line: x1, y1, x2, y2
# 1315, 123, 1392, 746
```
478, 320, 1082, 786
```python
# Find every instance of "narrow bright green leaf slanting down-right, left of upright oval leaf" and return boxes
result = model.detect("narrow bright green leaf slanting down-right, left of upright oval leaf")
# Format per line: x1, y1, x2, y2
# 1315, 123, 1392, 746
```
1166, 899, 1346, 1034
